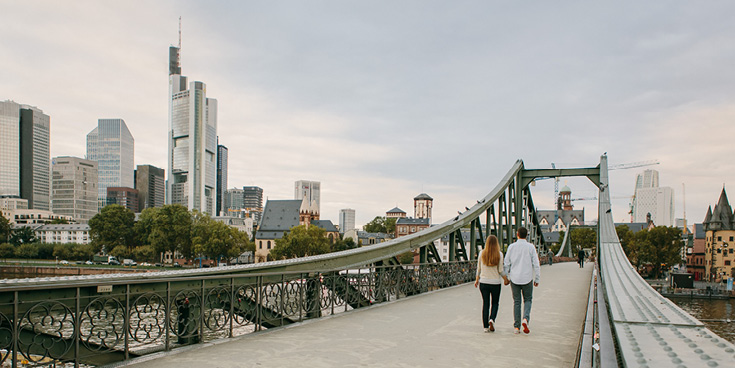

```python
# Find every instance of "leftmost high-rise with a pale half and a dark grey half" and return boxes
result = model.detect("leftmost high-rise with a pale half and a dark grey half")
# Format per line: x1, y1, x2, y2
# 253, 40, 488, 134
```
0, 101, 51, 211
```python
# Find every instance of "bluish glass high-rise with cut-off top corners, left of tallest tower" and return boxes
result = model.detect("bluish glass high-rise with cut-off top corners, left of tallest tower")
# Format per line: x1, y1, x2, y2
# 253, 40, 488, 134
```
87, 119, 135, 209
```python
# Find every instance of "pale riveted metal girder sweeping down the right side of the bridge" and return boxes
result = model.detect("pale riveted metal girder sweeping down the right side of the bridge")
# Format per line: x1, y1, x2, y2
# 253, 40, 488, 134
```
599, 156, 735, 367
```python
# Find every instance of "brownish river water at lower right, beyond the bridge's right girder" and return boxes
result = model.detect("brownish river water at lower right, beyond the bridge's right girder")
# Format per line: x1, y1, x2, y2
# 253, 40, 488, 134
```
669, 297, 735, 343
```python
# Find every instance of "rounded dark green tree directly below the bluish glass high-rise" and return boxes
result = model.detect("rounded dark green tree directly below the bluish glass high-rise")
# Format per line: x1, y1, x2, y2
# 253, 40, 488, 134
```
89, 204, 135, 252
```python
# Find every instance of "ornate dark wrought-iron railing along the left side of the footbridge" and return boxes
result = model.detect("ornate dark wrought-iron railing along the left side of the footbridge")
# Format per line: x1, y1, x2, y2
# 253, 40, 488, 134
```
0, 261, 476, 367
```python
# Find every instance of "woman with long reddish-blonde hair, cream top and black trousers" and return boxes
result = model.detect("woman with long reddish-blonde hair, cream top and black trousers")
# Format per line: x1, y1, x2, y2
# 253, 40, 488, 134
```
475, 235, 508, 332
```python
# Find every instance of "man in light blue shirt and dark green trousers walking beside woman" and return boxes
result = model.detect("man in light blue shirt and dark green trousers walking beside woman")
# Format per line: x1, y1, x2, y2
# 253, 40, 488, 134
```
503, 227, 541, 334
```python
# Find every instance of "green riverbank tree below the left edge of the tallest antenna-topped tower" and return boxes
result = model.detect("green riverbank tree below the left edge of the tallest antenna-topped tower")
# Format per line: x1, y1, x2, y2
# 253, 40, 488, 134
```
148, 204, 192, 258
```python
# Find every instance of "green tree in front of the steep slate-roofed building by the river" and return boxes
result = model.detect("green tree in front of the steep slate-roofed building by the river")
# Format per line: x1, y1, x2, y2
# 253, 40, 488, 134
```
270, 225, 329, 260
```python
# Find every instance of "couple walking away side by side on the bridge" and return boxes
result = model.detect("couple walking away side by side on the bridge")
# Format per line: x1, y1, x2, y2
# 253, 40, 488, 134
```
475, 227, 541, 334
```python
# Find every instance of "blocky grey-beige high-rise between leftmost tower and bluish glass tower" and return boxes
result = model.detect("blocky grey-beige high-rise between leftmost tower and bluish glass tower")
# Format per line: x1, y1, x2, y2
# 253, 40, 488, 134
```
51, 156, 98, 224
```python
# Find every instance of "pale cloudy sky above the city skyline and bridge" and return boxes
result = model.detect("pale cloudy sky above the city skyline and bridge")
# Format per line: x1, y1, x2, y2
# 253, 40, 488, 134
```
0, 0, 735, 227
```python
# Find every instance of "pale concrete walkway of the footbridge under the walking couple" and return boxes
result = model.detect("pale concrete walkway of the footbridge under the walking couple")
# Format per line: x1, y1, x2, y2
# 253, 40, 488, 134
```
123, 263, 593, 368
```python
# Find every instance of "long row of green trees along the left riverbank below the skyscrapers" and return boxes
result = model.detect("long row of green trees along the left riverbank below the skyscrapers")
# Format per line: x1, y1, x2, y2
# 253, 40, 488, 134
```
0, 204, 255, 262
